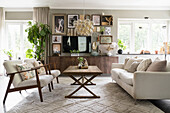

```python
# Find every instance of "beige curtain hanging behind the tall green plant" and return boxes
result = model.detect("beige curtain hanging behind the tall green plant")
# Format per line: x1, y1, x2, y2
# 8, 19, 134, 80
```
33, 7, 50, 63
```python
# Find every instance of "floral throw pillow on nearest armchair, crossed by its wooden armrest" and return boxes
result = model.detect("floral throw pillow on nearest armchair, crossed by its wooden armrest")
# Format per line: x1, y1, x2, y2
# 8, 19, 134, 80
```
16, 63, 35, 80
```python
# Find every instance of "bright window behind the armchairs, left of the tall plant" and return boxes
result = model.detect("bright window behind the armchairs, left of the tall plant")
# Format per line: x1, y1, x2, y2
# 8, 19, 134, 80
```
6, 21, 32, 59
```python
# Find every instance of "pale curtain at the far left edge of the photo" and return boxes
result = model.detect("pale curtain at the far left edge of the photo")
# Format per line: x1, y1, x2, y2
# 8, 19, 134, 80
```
0, 7, 6, 75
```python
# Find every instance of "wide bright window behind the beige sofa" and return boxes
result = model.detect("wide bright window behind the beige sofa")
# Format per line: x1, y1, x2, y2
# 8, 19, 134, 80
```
118, 19, 169, 53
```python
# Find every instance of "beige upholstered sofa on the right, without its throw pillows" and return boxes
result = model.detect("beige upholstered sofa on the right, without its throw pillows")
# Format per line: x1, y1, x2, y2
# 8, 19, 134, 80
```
111, 60, 170, 99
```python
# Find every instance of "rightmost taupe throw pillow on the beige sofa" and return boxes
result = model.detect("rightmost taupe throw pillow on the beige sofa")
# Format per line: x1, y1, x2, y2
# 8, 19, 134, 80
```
146, 60, 167, 72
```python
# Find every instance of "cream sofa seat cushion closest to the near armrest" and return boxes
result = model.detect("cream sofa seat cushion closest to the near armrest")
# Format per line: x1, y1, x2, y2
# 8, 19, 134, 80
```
119, 72, 134, 86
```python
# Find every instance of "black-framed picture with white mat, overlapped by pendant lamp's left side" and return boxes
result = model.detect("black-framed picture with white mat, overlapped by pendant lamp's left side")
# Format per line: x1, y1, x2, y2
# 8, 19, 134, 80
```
67, 14, 79, 28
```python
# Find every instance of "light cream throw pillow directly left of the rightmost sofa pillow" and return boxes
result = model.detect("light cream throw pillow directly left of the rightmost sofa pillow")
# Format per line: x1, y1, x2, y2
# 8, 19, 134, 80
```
137, 59, 152, 71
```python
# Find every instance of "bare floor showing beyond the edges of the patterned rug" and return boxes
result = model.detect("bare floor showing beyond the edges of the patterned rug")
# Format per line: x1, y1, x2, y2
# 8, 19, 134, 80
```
0, 75, 170, 113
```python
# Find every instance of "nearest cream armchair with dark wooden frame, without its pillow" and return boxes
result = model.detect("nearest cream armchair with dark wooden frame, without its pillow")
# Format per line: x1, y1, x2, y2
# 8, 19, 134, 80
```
3, 60, 53, 104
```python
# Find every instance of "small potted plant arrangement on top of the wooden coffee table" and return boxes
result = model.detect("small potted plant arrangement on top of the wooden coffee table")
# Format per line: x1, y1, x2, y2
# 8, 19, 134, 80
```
77, 57, 88, 69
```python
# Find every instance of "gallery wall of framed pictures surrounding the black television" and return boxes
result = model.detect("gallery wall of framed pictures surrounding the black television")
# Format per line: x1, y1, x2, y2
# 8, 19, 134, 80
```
51, 10, 114, 56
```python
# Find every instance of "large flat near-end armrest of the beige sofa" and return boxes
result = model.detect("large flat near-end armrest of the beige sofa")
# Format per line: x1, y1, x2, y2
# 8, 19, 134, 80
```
133, 72, 170, 99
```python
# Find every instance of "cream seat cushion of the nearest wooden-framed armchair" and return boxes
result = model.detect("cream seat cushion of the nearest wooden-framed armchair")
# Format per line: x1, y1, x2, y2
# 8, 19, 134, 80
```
17, 75, 53, 87
